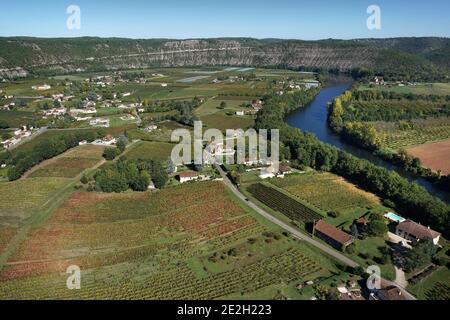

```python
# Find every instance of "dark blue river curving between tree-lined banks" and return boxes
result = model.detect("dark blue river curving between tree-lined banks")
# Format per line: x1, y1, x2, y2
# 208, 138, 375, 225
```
286, 82, 450, 202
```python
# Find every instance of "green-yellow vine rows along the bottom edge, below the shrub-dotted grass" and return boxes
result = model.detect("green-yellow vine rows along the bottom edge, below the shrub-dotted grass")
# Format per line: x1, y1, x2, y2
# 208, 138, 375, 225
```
0, 249, 322, 300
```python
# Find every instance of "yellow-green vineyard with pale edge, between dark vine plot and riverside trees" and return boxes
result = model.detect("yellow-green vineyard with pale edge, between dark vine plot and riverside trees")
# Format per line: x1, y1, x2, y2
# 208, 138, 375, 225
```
271, 173, 378, 211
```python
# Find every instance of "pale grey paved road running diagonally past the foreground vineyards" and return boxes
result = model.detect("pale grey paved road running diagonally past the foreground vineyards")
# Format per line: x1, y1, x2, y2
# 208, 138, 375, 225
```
215, 164, 416, 300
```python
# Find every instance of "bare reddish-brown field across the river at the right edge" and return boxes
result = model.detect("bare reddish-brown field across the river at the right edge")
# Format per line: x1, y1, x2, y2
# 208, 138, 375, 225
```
407, 139, 450, 175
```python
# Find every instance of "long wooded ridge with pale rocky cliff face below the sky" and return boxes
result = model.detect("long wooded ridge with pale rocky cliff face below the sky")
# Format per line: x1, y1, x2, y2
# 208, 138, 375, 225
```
0, 38, 444, 77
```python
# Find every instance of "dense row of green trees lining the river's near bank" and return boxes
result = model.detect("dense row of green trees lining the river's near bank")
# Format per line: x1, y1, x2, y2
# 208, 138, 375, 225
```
256, 87, 450, 233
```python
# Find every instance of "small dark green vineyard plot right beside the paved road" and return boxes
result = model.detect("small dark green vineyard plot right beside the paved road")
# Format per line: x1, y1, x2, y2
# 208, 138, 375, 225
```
248, 183, 322, 223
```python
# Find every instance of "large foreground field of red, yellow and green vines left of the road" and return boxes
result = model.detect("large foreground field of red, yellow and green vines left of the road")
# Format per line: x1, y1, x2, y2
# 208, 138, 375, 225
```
0, 182, 334, 299
